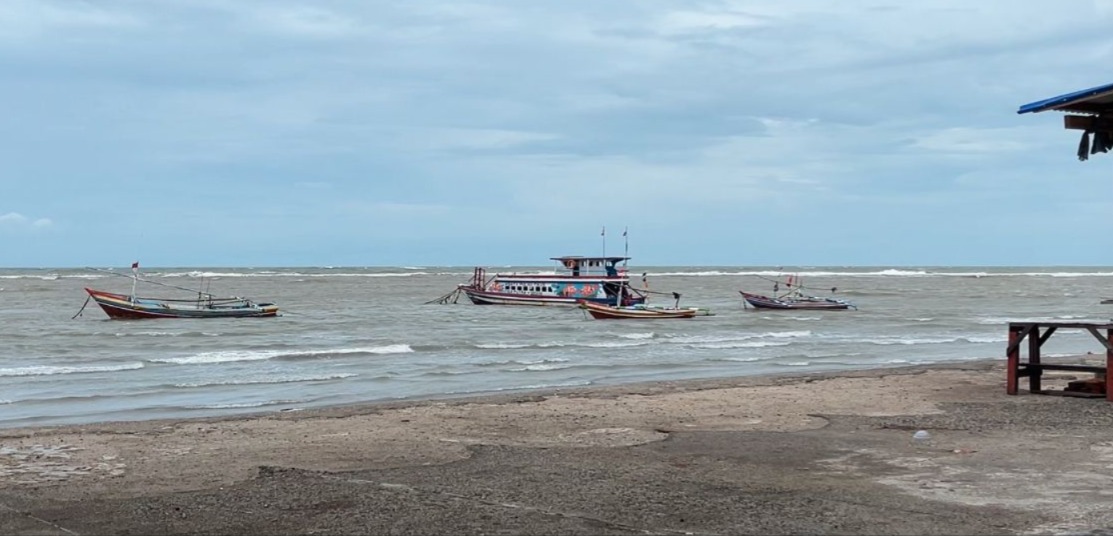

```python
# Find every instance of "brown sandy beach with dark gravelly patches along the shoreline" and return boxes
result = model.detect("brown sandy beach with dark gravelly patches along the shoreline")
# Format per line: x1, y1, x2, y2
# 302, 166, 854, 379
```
0, 356, 1113, 535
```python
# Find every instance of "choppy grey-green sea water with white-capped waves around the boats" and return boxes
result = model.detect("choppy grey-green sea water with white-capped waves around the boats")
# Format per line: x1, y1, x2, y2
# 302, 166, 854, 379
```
0, 266, 1113, 427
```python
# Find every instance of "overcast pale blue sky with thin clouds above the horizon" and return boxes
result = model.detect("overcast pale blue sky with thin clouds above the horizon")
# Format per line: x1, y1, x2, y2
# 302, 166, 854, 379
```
0, 0, 1113, 267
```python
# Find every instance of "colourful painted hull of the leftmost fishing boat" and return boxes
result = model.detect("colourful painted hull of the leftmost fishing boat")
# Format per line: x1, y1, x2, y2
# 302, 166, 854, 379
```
85, 288, 278, 320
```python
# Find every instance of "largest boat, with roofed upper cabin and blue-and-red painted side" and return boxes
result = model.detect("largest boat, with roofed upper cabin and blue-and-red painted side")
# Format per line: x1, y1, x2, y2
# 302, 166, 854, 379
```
456, 256, 646, 307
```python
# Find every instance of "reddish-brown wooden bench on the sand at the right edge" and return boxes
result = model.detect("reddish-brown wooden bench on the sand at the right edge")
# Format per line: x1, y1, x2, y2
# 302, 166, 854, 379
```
1005, 321, 1113, 401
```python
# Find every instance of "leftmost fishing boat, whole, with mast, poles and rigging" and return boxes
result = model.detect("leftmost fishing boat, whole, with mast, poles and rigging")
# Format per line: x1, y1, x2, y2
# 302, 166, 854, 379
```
73, 262, 278, 320
